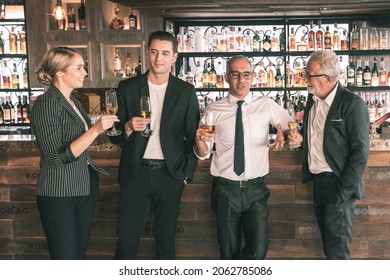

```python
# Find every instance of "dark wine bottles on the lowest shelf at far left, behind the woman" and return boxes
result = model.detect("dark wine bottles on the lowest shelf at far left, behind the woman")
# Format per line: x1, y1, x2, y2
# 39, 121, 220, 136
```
0, 94, 30, 125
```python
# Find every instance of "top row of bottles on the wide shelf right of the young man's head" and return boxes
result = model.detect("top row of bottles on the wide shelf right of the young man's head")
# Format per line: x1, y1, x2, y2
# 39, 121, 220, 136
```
169, 20, 389, 52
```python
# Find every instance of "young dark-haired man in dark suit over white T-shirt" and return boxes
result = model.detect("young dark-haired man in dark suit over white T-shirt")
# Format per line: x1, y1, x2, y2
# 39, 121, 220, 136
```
112, 31, 199, 259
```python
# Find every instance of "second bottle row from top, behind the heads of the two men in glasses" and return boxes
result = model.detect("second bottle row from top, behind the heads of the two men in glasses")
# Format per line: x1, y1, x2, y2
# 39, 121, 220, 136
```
178, 56, 390, 89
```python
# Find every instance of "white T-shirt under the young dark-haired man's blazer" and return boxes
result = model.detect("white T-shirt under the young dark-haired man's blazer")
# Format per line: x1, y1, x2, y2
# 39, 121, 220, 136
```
144, 82, 168, 159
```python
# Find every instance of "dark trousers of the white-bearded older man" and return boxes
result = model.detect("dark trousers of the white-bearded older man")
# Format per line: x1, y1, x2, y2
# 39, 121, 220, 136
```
313, 175, 356, 260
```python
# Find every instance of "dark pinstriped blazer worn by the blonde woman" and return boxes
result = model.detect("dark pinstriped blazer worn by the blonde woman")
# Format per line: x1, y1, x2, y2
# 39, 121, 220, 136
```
30, 85, 101, 197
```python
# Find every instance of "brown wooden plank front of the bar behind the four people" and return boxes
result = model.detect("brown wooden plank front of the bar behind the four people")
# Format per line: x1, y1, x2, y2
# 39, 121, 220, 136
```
0, 151, 390, 259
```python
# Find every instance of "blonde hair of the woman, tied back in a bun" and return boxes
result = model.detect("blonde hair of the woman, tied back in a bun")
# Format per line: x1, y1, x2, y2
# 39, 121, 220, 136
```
35, 47, 79, 86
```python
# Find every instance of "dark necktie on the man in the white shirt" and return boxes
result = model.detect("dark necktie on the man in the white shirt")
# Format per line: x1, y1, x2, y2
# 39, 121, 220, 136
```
234, 100, 245, 176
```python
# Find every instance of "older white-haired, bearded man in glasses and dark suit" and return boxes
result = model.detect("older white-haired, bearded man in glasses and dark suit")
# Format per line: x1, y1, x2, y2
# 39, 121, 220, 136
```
288, 50, 369, 259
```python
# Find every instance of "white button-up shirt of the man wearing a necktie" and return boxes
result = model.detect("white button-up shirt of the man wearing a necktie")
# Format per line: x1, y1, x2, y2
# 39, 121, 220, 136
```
197, 94, 291, 181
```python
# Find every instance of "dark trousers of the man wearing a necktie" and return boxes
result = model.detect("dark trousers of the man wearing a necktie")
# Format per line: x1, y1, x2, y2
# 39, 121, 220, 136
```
212, 177, 270, 260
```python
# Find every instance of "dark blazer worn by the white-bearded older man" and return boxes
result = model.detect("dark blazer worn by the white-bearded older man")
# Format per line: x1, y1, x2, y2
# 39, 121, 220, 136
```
302, 84, 370, 201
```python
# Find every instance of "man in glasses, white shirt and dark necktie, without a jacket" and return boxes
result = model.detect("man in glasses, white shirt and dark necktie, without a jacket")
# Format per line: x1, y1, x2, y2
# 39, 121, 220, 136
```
194, 56, 291, 259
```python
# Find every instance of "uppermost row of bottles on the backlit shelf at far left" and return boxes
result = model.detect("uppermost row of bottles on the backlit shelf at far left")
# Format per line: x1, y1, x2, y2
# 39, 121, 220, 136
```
0, 25, 27, 55
